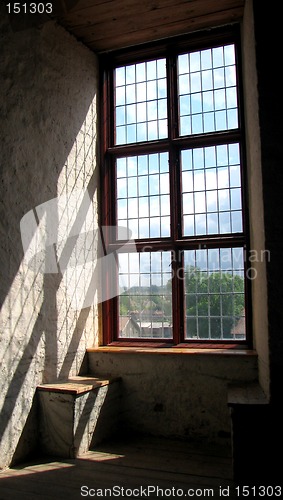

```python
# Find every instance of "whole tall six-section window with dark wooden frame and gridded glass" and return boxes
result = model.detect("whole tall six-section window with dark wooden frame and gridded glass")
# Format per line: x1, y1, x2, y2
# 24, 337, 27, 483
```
102, 28, 249, 345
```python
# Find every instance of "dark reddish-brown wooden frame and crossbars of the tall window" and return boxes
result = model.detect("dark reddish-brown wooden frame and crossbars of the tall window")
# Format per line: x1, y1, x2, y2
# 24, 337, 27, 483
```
100, 24, 252, 348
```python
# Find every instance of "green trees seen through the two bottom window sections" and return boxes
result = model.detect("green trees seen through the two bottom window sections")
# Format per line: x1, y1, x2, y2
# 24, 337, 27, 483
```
120, 266, 245, 340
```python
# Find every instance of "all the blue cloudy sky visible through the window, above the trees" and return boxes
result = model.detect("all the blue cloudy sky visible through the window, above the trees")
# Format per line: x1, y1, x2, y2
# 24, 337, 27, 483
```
115, 45, 243, 294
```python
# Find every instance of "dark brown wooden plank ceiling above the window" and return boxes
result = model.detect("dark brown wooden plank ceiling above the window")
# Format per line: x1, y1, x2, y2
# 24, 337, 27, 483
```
52, 0, 244, 53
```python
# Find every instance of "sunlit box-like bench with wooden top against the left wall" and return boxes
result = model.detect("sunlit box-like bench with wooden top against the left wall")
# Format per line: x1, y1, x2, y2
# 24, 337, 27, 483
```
37, 376, 121, 458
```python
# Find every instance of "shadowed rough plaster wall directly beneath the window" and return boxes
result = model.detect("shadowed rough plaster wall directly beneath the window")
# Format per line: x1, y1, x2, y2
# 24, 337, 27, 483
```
89, 352, 257, 446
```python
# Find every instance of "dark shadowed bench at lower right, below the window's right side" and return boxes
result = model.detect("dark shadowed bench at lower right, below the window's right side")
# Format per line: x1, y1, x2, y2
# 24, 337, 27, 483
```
228, 383, 270, 481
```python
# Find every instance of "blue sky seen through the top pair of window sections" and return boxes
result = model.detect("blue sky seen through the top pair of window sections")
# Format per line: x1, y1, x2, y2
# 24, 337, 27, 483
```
115, 45, 238, 144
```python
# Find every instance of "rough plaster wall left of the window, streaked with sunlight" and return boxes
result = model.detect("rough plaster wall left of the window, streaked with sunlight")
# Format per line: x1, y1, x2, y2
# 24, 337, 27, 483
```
0, 5, 98, 467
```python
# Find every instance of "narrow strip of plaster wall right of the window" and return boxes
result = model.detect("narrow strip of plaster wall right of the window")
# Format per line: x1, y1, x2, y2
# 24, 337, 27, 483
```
243, 0, 270, 396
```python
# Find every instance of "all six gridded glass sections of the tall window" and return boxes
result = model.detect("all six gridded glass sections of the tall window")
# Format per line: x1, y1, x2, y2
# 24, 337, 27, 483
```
114, 44, 245, 340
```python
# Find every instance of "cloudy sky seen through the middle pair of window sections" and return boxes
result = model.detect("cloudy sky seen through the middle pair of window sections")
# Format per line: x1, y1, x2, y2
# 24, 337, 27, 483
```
117, 144, 242, 238
